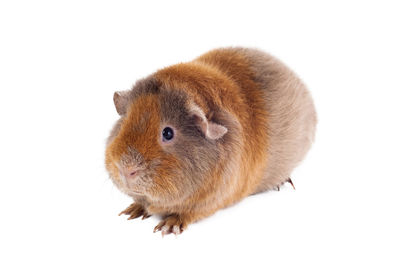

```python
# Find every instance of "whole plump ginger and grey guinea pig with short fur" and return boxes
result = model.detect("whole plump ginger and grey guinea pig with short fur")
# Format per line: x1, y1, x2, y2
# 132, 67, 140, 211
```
105, 48, 317, 235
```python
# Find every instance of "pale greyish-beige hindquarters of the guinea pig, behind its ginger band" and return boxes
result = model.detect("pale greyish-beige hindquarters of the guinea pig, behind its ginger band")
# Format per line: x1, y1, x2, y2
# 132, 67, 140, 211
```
241, 48, 317, 193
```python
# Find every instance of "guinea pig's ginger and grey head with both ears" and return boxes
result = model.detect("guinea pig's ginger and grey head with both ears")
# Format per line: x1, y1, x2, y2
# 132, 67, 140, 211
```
106, 78, 228, 204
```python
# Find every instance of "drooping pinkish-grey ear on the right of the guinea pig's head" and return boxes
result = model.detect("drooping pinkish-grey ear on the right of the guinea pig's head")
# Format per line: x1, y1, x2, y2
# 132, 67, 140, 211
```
190, 103, 228, 140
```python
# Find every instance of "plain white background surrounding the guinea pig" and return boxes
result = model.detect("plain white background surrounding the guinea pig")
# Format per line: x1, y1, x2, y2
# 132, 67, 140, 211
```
0, 0, 400, 266
